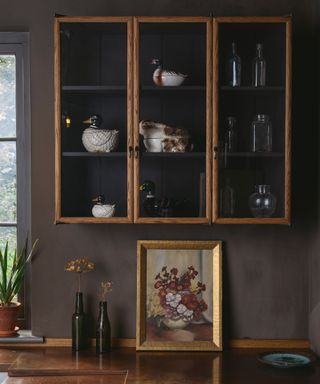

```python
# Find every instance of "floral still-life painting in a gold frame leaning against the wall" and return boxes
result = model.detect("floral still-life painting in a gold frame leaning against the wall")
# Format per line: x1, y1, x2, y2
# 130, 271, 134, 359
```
136, 240, 222, 351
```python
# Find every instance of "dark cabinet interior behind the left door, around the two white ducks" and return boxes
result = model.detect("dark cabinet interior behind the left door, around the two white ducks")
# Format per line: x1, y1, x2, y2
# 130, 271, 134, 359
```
59, 21, 131, 220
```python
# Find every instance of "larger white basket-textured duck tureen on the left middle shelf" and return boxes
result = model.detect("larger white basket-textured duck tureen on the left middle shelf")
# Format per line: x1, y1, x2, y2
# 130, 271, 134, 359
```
82, 115, 119, 152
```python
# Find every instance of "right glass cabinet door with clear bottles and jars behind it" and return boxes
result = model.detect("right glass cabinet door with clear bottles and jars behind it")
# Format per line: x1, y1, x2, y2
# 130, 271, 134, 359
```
213, 18, 291, 224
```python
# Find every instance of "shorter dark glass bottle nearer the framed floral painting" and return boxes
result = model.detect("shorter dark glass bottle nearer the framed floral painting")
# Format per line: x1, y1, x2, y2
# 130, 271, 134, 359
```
96, 301, 111, 354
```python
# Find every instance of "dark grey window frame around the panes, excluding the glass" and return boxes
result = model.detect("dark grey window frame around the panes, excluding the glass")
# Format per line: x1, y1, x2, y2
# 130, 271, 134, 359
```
0, 32, 32, 327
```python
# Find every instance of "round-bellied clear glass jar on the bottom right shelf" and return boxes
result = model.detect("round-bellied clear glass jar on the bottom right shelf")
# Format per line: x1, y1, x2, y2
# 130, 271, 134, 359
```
249, 184, 277, 217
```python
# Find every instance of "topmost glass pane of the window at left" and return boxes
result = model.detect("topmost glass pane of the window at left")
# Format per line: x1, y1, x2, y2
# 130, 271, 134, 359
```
0, 55, 16, 137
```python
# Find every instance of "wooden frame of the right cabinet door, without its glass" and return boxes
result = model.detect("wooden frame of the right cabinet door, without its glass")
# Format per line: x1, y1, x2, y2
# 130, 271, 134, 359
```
212, 16, 292, 225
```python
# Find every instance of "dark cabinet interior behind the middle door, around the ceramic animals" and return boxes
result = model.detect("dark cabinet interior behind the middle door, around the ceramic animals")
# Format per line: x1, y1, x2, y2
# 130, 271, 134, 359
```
135, 20, 211, 222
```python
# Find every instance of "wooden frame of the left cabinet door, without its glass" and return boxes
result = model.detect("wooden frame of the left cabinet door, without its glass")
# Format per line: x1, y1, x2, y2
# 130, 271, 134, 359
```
54, 16, 133, 224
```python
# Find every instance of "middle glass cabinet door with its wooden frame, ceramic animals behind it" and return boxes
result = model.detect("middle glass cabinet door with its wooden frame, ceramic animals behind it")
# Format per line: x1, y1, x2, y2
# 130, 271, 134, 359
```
134, 17, 212, 223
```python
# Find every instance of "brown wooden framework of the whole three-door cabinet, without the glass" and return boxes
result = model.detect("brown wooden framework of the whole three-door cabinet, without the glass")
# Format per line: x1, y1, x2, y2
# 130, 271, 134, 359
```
54, 17, 292, 224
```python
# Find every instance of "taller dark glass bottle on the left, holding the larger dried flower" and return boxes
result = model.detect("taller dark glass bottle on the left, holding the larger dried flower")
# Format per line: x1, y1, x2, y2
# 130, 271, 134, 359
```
72, 292, 87, 351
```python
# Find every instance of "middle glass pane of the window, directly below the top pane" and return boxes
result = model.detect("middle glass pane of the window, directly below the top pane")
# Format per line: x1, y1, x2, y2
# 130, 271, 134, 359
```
0, 142, 17, 222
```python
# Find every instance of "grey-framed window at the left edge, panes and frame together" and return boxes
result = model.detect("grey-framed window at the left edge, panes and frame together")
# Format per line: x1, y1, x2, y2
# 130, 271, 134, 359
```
0, 32, 31, 324
